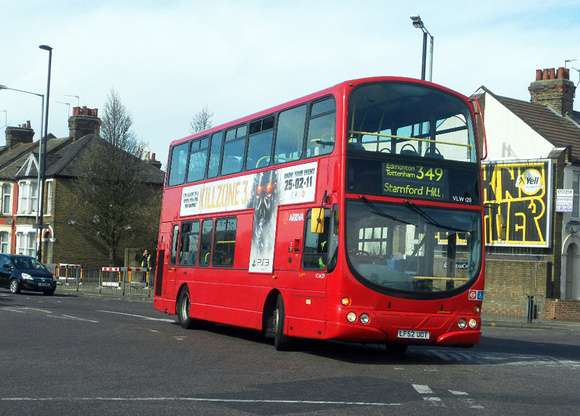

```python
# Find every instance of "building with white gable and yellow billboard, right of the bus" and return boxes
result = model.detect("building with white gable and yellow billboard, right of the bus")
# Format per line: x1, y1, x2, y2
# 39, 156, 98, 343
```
478, 68, 580, 320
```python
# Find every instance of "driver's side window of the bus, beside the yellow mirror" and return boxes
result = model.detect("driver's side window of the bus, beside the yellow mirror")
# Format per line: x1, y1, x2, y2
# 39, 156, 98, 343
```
302, 209, 330, 270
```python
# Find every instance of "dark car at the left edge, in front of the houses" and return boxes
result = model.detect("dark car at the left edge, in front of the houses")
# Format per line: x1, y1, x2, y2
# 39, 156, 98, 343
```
0, 254, 56, 296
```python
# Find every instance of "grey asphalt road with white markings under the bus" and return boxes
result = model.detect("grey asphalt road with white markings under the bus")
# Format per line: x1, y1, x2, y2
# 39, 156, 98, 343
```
0, 289, 580, 416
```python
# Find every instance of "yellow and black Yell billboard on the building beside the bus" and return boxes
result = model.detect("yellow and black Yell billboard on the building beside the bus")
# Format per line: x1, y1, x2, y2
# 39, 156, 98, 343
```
482, 160, 552, 247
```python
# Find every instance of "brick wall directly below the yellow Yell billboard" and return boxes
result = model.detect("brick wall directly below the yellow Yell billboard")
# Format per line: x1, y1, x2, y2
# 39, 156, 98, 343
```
483, 257, 551, 319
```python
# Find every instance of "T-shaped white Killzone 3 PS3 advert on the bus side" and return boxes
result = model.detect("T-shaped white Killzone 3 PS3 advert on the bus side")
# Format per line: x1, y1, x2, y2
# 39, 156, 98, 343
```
179, 162, 318, 273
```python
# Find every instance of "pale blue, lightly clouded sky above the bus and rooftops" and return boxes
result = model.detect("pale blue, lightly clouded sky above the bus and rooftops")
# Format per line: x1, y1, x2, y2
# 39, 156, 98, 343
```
0, 0, 580, 163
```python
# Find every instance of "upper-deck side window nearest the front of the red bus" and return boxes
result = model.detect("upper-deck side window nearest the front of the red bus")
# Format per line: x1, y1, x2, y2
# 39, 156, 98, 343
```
306, 97, 336, 157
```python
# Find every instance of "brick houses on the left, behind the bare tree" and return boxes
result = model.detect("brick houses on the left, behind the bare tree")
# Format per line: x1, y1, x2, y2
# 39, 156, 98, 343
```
0, 107, 164, 267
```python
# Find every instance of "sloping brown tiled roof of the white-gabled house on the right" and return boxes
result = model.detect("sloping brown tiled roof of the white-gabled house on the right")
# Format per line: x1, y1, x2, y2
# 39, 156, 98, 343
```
494, 95, 580, 161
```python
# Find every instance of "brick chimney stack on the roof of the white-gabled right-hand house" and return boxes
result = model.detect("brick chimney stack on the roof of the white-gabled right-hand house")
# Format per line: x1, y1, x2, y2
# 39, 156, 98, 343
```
528, 67, 576, 116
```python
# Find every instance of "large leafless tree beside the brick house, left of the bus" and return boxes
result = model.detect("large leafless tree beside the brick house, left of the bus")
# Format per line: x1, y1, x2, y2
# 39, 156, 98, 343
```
75, 91, 161, 264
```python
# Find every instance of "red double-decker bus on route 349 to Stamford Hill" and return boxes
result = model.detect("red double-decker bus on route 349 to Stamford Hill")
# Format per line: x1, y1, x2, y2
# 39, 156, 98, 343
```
154, 77, 484, 351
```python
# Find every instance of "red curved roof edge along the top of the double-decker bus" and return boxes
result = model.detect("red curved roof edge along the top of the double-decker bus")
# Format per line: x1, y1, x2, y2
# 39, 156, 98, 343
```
170, 76, 468, 146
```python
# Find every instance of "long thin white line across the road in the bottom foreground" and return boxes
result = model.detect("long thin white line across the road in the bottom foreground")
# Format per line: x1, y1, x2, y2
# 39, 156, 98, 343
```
0, 397, 401, 407
